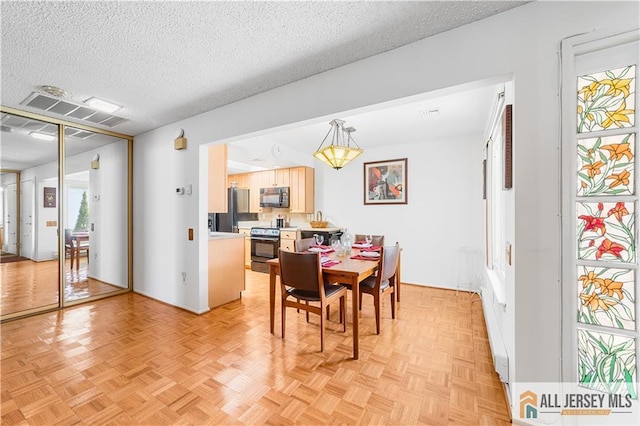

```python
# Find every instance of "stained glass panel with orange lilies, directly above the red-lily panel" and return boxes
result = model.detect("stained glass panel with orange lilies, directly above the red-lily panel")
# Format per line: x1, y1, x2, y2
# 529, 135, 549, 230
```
578, 133, 635, 197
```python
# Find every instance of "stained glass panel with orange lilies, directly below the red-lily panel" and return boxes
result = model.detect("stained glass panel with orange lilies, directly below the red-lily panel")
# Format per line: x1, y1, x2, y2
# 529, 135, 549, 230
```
577, 266, 636, 330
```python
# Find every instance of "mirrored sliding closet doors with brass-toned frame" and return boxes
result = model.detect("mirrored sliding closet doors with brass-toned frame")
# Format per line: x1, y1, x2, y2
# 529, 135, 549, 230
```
0, 108, 133, 321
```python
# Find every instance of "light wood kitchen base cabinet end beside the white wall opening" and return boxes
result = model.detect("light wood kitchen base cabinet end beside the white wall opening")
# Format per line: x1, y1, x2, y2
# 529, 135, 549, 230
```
209, 232, 245, 308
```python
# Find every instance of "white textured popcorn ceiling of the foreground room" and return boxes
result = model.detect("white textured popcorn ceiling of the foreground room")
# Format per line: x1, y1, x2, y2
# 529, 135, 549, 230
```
0, 1, 525, 139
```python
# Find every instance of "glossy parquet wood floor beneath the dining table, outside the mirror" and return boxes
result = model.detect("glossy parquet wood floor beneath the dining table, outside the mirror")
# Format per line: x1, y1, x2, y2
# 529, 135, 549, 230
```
0, 271, 509, 425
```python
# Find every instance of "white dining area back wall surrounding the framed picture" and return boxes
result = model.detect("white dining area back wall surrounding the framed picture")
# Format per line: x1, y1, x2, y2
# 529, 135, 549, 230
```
315, 135, 484, 289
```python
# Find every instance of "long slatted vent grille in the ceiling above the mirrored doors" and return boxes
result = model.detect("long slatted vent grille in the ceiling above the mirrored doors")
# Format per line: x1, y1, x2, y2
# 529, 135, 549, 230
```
20, 92, 127, 127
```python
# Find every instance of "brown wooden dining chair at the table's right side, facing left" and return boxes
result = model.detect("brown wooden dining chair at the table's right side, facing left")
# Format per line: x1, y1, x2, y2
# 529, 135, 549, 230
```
360, 243, 400, 334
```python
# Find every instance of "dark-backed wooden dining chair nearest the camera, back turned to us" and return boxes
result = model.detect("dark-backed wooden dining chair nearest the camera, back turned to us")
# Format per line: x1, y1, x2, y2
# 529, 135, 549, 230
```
278, 249, 347, 352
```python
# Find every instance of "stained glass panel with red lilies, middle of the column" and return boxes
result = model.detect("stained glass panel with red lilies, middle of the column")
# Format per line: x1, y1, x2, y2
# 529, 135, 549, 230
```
576, 201, 636, 263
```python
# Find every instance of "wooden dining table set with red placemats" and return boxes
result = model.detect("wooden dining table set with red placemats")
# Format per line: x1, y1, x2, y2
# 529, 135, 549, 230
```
266, 249, 378, 359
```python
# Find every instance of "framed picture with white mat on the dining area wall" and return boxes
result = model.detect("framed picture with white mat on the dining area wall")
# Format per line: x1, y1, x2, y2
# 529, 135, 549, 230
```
364, 158, 407, 205
